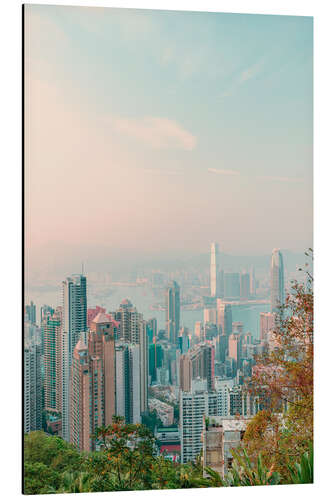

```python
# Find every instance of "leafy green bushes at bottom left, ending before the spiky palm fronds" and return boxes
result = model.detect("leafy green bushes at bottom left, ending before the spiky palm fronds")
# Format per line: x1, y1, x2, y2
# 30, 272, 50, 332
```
24, 426, 204, 494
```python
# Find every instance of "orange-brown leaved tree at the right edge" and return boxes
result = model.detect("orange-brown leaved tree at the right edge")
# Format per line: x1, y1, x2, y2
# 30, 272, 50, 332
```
244, 251, 313, 483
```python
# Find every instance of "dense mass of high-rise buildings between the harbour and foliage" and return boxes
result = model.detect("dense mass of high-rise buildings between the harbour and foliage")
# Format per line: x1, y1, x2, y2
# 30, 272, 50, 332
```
24, 244, 308, 484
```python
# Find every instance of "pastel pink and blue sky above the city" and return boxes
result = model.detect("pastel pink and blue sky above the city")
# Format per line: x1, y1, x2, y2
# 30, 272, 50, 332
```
25, 5, 312, 270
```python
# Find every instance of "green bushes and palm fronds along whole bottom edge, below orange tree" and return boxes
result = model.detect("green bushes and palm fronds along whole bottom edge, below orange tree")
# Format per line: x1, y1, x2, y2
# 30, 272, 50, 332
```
24, 423, 313, 495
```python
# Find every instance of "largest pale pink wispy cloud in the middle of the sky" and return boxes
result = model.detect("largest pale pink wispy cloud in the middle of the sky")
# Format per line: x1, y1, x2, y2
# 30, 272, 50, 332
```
114, 116, 197, 151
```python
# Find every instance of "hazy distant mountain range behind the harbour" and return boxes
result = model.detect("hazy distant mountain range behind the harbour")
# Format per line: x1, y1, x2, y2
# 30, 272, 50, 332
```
26, 243, 306, 284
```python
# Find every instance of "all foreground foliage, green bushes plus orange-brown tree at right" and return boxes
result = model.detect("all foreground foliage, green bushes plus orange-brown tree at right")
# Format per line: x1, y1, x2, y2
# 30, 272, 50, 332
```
24, 260, 313, 494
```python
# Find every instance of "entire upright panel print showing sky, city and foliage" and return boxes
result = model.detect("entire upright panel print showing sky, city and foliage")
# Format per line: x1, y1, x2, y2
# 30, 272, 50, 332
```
22, 4, 313, 494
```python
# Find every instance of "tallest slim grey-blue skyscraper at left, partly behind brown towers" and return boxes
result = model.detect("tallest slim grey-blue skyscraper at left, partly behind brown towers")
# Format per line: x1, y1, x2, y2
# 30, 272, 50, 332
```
61, 275, 87, 441
